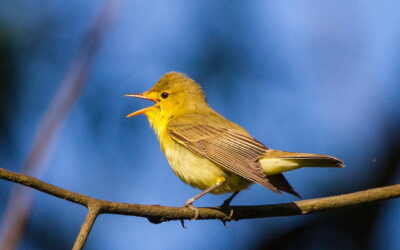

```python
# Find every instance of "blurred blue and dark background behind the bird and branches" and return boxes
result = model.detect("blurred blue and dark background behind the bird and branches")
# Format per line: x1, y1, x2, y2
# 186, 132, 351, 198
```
0, 0, 400, 249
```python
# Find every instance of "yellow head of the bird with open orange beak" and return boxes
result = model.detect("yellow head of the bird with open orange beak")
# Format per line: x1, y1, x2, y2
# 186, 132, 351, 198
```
125, 72, 208, 126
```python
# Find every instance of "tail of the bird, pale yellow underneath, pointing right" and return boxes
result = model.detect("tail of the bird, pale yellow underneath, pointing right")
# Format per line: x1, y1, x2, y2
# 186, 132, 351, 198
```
259, 149, 344, 175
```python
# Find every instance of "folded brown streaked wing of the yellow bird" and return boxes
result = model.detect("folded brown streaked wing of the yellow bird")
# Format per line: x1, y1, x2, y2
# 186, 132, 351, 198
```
168, 122, 280, 193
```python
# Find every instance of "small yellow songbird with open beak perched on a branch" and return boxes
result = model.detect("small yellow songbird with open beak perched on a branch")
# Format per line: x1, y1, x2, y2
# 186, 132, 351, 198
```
125, 72, 344, 219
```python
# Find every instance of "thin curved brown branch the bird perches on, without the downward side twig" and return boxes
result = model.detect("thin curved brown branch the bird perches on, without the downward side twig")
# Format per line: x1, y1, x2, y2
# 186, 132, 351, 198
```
0, 168, 400, 223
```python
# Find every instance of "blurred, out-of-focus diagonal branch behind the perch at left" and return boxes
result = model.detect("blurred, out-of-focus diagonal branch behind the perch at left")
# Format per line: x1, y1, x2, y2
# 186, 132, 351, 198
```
0, 0, 123, 249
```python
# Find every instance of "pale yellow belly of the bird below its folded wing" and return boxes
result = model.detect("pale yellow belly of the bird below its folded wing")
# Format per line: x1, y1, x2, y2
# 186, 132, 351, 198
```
163, 142, 251, 194
